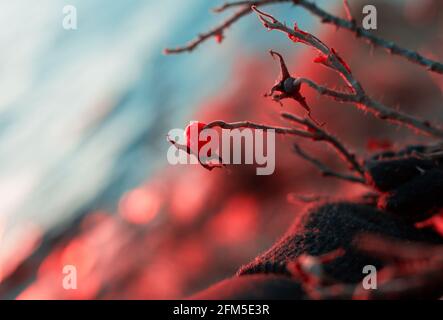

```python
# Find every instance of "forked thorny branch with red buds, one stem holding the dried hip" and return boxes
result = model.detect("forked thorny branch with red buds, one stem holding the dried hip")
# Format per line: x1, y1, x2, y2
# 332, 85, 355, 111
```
252, 6, 443, 138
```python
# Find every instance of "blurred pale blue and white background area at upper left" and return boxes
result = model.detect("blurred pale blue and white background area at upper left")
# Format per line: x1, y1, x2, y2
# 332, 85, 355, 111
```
0, 0, 326, 249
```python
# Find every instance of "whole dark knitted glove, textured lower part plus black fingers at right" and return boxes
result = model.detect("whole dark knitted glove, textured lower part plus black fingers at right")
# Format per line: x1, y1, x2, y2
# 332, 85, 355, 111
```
238, 146, 443, 283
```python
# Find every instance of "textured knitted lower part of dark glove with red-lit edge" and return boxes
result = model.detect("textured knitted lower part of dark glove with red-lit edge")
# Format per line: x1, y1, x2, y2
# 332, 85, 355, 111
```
238, 203, 443, 283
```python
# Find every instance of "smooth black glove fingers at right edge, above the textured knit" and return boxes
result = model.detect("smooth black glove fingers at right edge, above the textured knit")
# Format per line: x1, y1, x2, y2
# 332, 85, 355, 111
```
365, 146, 443, 222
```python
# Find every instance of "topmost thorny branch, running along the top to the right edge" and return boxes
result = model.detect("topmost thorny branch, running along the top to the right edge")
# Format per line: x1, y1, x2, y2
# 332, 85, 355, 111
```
165, 0, 443, 74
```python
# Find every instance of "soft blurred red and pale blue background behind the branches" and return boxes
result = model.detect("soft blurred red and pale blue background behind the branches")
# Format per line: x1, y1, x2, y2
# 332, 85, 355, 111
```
0, 0, 443, 299
